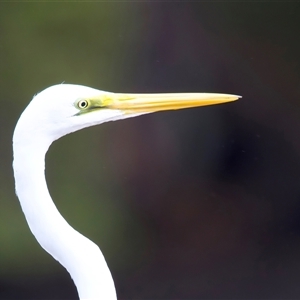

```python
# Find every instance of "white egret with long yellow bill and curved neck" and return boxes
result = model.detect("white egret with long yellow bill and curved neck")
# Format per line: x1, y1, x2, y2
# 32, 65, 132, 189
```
13, 84, 239, 300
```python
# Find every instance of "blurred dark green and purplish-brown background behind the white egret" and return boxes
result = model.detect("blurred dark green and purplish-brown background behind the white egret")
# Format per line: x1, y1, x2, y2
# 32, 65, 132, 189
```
0, 1, 300, 300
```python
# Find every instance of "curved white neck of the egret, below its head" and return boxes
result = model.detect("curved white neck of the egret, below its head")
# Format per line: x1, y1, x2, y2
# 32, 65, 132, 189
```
13, 132, 117, 300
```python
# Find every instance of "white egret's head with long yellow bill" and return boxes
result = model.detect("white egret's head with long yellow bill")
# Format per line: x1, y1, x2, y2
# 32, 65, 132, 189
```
15, 84, 239, 144
